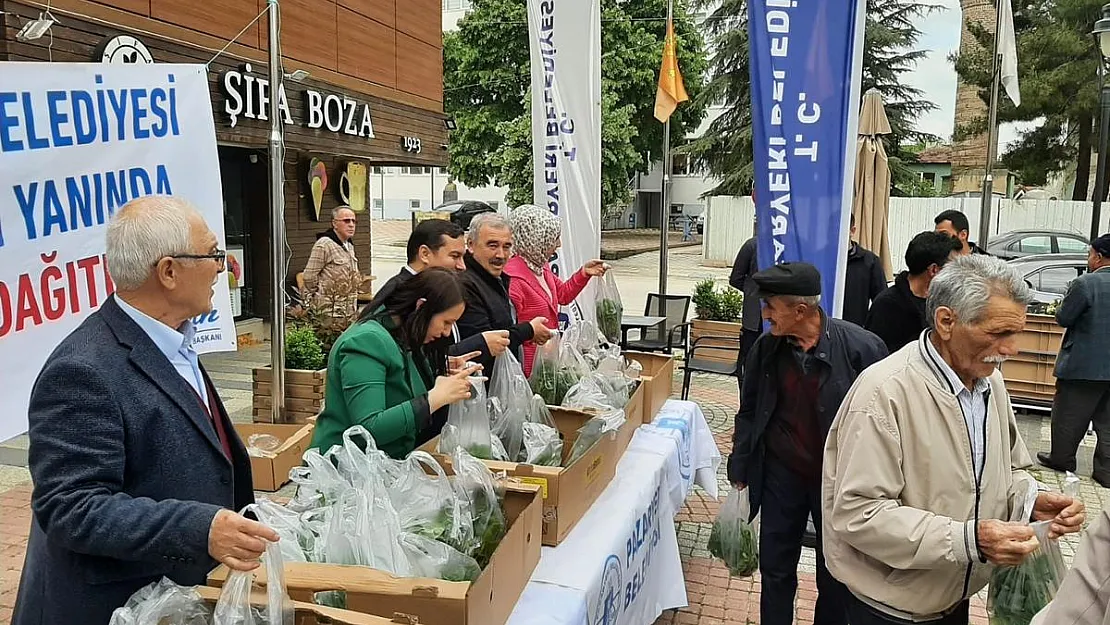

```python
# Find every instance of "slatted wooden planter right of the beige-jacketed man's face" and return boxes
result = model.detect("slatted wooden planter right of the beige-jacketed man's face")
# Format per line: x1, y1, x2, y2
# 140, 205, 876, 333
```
1002, 314, 1064, 404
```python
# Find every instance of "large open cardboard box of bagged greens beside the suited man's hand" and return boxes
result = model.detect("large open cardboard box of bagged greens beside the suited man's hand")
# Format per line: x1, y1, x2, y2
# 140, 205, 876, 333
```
208, 483, 543, 625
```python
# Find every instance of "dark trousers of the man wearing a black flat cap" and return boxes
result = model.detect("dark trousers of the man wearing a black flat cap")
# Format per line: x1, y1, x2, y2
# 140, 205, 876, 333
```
759, 456, 843, 625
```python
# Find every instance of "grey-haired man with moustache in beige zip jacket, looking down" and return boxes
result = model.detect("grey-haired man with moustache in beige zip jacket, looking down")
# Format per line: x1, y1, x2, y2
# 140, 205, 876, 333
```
821, 255, 1084, 625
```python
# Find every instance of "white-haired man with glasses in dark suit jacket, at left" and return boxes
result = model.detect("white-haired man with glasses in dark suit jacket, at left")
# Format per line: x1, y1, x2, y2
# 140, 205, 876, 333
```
12, 196, 278, 625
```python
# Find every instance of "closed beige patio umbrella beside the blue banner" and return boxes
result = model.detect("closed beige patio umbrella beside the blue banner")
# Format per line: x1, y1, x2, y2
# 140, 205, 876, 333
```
851, 89, 891, 280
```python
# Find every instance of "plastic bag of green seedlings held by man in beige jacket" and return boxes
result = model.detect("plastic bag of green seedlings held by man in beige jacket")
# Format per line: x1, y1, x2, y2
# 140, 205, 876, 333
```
987, 521, 1068, 625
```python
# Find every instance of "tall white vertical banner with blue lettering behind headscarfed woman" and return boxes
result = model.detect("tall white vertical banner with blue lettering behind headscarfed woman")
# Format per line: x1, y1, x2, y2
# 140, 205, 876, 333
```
528, 0, 602, 321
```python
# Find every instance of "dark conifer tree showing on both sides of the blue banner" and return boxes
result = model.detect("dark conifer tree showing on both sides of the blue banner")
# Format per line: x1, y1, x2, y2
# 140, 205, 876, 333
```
685, 0, 937, 195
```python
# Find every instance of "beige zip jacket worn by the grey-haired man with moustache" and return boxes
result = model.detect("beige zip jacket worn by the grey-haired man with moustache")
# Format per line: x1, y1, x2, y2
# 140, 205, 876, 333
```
821, 334, 1036, 621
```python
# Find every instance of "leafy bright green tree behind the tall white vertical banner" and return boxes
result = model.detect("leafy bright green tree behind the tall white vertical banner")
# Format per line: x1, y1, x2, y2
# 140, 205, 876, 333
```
443, 0, 708, 217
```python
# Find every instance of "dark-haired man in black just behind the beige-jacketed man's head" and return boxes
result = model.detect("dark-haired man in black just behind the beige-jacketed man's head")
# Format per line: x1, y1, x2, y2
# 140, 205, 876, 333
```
864, 232, 963, 354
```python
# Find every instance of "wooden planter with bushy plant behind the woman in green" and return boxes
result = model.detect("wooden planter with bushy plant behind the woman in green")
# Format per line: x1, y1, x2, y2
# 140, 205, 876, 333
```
252, 272, 363, 423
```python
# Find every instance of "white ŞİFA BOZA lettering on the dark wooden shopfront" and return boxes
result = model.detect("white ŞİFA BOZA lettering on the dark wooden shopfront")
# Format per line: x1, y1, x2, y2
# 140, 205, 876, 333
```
220, 63, 374, 139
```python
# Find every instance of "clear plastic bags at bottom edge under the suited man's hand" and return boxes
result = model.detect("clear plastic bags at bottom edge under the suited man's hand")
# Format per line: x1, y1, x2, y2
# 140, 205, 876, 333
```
109, 515, 295, 625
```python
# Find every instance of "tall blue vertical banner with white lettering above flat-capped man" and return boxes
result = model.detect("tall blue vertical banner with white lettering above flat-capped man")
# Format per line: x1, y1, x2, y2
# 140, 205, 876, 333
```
748, 0, 866, 316
